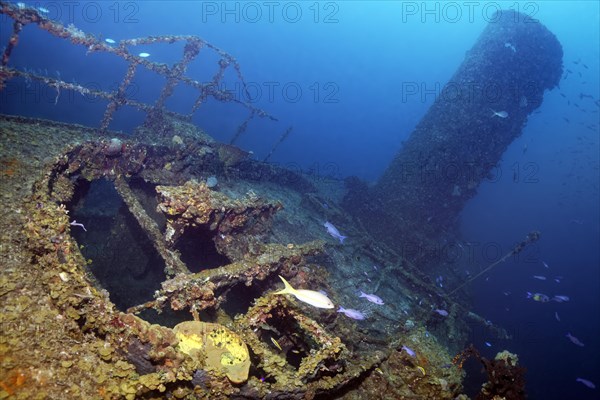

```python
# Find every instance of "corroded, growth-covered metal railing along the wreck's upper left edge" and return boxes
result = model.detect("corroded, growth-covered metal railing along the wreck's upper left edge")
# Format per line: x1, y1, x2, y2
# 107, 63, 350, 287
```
0, 1, 284, 144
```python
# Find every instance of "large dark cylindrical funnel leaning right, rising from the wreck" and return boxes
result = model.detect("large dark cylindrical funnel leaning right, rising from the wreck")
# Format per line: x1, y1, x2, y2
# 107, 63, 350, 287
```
344, 9, 563, 271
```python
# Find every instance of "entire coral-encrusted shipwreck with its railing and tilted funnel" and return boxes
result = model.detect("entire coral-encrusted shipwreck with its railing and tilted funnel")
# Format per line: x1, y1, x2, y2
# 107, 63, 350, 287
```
0, 1, 562, 399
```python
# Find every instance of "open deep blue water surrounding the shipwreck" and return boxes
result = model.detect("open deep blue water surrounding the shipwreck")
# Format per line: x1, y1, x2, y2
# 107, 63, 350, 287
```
0, 1, 600, 400
